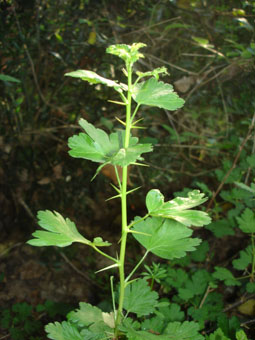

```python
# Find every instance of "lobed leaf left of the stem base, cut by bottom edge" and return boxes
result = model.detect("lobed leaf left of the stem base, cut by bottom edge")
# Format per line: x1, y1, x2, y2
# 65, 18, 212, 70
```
45, 321, 83, 340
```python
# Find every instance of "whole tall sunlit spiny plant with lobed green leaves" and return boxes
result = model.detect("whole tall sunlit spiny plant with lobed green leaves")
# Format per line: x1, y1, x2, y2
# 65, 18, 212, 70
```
28, 43, 210, 340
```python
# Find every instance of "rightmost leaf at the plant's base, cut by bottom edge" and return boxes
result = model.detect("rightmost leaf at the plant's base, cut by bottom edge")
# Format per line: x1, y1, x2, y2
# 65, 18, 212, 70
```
164, 321, 204, 340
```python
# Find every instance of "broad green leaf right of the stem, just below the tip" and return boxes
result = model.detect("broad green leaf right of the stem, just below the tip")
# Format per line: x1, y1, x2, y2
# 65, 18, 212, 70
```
132, 78, 184, 110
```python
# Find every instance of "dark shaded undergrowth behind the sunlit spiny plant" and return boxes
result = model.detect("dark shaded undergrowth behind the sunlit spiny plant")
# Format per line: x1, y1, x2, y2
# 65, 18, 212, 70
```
0, 0, 255, 339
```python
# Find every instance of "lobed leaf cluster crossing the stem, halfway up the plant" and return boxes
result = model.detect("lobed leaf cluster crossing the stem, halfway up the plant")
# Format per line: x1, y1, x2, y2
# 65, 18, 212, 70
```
68, 119, 152, 167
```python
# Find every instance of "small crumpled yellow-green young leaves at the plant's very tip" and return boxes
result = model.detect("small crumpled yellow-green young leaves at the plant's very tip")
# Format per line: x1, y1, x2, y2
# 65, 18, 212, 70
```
106, 43, 146, 66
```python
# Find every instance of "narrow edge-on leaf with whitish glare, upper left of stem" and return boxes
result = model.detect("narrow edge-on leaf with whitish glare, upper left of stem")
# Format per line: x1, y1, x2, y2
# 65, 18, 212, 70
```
65, 70, 123, 89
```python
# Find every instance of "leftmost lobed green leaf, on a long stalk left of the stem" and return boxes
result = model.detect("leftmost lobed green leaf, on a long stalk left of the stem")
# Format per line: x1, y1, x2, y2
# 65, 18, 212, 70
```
27, 210, 91, 247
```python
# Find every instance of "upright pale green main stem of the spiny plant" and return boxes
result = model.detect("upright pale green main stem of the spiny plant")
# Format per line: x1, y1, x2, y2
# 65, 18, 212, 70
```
114, 63, 132, 339
